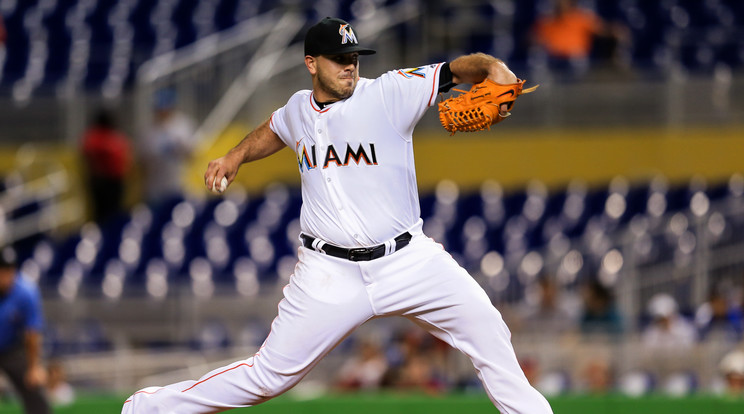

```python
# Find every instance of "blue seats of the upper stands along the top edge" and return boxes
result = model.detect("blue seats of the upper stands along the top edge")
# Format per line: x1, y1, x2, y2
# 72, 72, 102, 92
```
0, 0, 744, 97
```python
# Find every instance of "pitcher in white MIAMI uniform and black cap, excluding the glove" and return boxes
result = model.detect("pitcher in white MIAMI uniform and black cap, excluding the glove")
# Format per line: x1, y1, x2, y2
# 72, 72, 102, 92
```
122, 17, 552, 414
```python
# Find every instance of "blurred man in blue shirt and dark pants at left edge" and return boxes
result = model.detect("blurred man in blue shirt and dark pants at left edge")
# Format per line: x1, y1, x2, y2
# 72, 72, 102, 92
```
0, 248, 51, 414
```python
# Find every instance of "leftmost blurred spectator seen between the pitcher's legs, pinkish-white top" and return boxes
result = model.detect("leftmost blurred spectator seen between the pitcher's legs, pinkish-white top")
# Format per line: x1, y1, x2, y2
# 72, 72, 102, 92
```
336, 340, 388, 391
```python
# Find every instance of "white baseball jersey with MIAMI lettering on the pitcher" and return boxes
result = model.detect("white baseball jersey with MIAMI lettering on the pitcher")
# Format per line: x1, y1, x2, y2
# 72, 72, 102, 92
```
270, 63, 442, 247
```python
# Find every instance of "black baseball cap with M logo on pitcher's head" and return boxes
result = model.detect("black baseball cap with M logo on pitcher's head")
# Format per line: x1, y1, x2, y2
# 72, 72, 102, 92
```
305, 17, 376, 56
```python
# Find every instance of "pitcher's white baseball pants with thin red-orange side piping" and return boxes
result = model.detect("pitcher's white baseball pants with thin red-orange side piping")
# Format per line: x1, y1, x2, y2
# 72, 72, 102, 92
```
122, 232, 552, 414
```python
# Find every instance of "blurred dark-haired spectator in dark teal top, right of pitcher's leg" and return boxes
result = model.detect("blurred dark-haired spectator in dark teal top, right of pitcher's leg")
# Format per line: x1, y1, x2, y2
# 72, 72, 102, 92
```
581, 280, 623, 335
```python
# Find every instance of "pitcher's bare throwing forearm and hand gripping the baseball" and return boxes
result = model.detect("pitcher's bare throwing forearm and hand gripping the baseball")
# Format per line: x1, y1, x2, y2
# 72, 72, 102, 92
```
204, 120, 285, 190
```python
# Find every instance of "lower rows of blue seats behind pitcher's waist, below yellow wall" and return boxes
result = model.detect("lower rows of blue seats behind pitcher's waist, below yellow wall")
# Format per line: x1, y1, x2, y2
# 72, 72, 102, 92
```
11, 175, 744, 299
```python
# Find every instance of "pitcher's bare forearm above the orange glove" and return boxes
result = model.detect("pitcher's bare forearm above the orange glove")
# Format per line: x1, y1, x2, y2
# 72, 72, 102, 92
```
450, 53, 517, 85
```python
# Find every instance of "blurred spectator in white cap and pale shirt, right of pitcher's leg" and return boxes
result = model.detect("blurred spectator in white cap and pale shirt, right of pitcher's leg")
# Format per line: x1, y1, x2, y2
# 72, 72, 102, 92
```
643, 293, 697, 351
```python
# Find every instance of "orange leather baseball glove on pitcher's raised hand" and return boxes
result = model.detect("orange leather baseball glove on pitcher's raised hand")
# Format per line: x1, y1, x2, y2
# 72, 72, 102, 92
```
439, 79, 540, 135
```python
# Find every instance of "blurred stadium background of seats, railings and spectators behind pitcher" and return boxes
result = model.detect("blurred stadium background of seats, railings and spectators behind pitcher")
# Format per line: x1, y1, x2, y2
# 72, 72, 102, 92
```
0, 0, 744, 410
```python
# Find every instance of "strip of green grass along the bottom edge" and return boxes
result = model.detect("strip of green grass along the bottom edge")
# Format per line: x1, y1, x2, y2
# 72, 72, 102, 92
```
0, 394, 744, 414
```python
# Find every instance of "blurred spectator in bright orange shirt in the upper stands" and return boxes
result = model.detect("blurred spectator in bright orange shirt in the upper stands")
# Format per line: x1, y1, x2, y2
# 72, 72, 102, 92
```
532, 0, 629, 74
